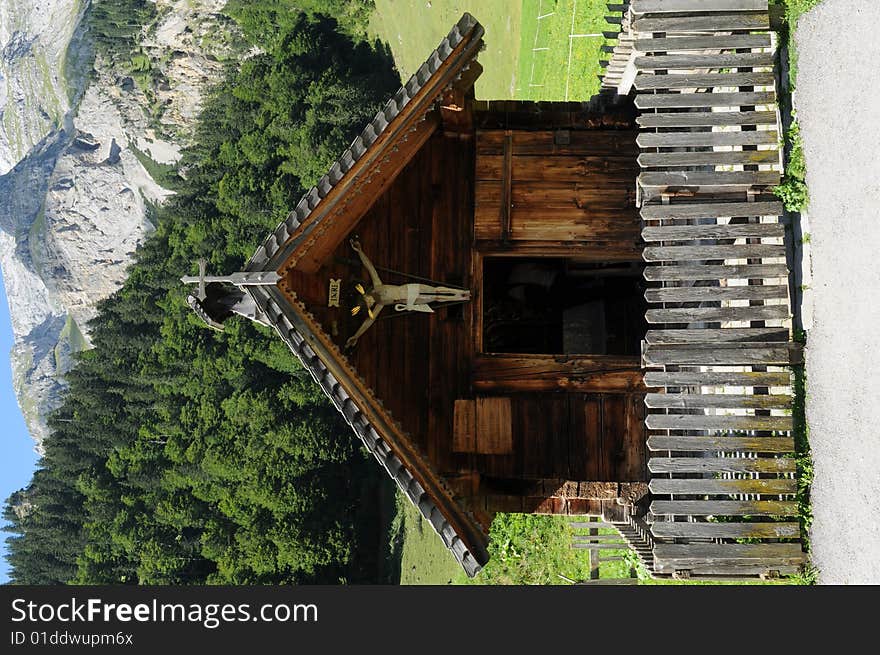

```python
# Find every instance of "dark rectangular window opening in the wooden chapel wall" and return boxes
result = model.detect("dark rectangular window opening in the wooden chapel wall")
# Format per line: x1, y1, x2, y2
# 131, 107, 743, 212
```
483, 257, 647, 356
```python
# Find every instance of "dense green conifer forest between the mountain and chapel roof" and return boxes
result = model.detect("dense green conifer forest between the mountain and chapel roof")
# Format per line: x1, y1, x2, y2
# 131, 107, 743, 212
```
4, 0, 399, 584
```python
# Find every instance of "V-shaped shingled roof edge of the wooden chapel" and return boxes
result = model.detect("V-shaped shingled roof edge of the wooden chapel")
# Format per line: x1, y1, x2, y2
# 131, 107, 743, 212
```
245, 13, 488, 576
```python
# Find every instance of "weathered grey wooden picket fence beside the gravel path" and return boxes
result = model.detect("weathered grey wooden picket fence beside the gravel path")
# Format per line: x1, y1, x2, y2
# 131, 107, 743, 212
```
630, 0, 804, 577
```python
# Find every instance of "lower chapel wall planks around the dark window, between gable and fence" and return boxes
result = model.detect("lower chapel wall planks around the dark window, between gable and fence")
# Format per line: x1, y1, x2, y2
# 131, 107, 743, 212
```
472, 118, 647, 485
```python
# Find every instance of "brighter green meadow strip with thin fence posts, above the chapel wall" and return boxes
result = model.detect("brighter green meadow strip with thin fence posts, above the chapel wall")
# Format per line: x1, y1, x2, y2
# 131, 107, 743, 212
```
516, 0, 612, 100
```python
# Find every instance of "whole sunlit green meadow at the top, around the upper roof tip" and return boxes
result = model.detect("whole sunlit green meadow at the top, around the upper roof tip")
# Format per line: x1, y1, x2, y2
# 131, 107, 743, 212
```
369, 0, 611, 100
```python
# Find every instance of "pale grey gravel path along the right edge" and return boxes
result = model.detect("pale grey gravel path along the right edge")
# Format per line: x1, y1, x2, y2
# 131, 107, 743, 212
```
794, 0, 880, 584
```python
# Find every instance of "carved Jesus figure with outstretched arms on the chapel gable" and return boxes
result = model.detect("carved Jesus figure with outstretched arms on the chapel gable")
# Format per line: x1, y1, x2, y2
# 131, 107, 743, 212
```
345, 239, 471, 348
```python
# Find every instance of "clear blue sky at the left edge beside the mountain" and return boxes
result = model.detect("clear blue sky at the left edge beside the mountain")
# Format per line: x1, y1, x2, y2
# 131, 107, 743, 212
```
0, 274, 37, 583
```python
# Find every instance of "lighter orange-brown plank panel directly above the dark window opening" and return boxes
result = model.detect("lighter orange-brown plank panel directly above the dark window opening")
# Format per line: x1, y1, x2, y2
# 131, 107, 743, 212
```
474, 130, 640, 250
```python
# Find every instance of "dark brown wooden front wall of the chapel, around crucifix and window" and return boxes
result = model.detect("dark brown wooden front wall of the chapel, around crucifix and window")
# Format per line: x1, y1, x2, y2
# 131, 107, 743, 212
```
286, 116, 646, 516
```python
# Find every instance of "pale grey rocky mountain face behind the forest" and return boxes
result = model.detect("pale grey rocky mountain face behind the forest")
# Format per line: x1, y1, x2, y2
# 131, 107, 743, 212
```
0, 0, 235, 450
